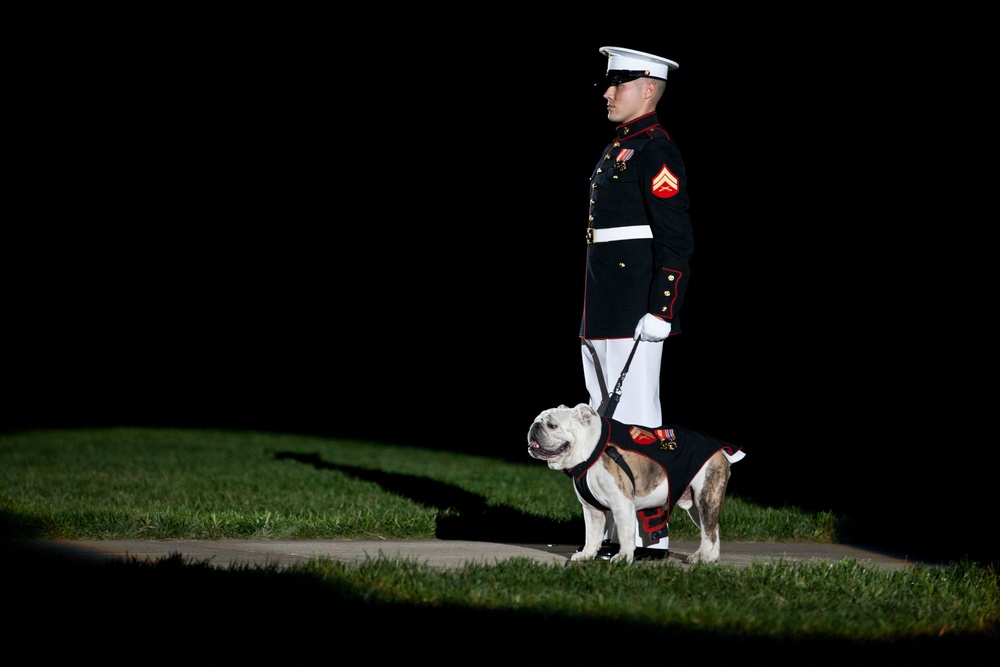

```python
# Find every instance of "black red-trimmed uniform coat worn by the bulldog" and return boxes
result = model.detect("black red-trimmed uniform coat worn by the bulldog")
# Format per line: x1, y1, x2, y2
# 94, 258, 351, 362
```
563, 417, 744, 540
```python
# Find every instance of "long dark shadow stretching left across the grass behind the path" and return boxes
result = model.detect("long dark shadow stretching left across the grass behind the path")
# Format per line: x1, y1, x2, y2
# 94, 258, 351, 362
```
274, 452, 584, 544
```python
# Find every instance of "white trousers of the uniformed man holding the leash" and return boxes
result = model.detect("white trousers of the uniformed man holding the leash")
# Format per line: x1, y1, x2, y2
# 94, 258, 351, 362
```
580, 338, 670, 549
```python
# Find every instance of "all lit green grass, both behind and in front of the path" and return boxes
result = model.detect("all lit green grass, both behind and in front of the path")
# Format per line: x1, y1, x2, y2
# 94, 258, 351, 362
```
0, 428, 1000, 662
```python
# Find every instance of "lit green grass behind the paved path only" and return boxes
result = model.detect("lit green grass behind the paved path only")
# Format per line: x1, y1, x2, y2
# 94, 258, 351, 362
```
0, 429, 838, 542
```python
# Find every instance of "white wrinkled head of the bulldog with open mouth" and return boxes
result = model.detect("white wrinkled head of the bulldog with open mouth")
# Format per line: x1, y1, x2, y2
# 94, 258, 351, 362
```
528, 403, 600, 470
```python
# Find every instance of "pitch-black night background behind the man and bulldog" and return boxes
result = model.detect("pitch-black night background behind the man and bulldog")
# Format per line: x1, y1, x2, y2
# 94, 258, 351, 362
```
2, 15, 992, 558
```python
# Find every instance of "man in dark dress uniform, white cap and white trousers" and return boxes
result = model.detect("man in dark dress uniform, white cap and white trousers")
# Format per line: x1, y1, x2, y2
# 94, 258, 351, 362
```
580, 46, 694, 558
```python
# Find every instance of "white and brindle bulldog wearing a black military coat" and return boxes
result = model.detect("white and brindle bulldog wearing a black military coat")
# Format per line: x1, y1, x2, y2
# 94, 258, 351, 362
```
528, 403, 744, 563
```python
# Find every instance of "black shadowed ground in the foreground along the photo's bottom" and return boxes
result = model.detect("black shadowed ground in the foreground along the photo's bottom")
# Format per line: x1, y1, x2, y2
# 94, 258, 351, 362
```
0, 541, 998, 667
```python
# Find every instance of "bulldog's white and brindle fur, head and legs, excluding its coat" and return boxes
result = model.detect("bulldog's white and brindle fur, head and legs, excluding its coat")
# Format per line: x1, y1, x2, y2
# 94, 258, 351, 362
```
528, 403, 730, 563
